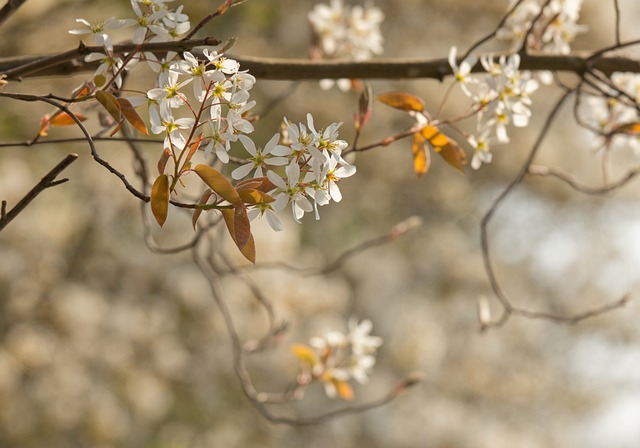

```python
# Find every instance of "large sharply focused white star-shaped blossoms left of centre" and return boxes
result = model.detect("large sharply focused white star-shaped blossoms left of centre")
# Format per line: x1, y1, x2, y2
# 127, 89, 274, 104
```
71, 0, 360, 230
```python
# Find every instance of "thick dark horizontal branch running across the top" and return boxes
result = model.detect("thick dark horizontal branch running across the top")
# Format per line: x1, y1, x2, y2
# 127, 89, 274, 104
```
0, 50, 640, 80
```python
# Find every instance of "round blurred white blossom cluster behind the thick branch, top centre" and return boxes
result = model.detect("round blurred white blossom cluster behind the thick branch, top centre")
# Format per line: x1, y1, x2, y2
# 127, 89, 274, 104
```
308, 0, 384, 91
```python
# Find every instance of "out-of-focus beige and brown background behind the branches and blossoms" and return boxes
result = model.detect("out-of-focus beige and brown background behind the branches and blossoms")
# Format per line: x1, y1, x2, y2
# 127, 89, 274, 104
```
0, 0, 640, 448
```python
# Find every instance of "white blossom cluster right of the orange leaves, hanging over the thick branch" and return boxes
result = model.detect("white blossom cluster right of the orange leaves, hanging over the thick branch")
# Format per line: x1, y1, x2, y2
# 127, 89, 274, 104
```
449, 47, 539, 169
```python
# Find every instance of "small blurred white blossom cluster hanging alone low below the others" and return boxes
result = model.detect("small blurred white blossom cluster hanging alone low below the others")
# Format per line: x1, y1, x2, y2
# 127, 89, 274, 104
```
302, 319, 382, 397
